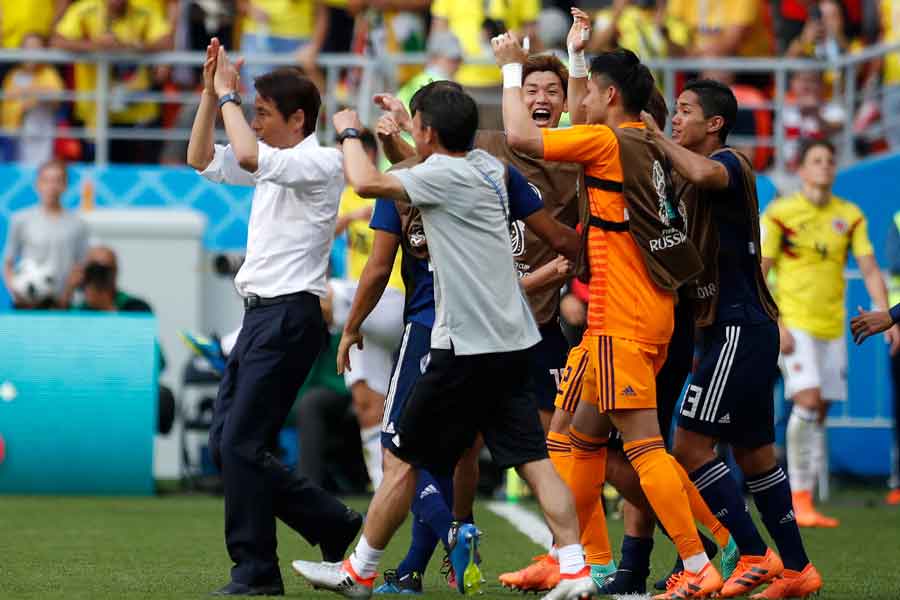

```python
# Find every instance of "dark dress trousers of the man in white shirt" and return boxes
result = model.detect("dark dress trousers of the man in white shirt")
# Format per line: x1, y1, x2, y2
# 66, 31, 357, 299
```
209, 294, 347, 585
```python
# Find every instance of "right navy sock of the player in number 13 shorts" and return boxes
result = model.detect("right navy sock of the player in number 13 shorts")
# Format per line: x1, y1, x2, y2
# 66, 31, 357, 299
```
747, 466, 809, 571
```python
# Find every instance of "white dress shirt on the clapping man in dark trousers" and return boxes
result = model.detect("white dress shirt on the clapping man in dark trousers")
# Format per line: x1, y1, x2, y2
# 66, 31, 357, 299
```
200, 134, 344, 298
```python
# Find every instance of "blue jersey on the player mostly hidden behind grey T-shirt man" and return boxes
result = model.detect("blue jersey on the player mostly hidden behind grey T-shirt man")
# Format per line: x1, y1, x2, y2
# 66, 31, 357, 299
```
369, 167, 544, 327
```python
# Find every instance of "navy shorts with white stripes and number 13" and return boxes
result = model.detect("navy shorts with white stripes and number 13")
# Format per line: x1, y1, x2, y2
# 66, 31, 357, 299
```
678, 321, 778, 449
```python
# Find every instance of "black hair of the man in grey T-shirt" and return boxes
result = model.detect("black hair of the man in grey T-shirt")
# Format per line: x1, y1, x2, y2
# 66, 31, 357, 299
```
410, 81, 478, 152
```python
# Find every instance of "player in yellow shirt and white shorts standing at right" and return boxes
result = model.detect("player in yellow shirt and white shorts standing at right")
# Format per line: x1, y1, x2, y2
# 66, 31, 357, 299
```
762, 140, 900, 527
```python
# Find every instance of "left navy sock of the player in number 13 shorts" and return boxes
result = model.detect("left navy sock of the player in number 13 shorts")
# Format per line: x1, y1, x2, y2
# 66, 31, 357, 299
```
691, 458, 766, 556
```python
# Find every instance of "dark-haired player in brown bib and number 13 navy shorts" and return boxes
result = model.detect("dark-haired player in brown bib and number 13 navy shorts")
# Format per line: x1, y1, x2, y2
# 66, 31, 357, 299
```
644, 80, 822, 598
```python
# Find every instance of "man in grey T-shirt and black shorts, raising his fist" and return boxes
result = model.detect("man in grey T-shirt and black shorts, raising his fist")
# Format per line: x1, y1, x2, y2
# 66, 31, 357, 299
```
293, 84, 595, 599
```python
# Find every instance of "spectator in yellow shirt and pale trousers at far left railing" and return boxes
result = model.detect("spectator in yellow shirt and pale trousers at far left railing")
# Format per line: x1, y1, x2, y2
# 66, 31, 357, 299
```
0, 33, 64, 166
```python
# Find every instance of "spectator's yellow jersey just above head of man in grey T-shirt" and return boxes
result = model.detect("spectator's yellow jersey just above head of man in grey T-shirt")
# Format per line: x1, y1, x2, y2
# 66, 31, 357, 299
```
431, 0, 541, 87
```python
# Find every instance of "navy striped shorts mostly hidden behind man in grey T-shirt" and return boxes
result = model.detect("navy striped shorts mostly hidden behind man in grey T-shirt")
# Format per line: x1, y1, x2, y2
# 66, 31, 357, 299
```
381, 321, 431, 454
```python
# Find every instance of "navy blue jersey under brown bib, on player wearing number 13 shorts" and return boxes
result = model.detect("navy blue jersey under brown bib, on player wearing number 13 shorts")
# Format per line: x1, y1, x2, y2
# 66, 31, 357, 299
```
708, 152, 770, 323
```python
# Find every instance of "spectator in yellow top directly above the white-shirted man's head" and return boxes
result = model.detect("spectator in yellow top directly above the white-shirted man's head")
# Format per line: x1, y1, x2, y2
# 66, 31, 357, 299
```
238, 0, 329, 91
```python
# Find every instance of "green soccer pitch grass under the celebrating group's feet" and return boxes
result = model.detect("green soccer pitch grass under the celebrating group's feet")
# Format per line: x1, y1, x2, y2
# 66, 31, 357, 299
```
0, 490, 900, 600
